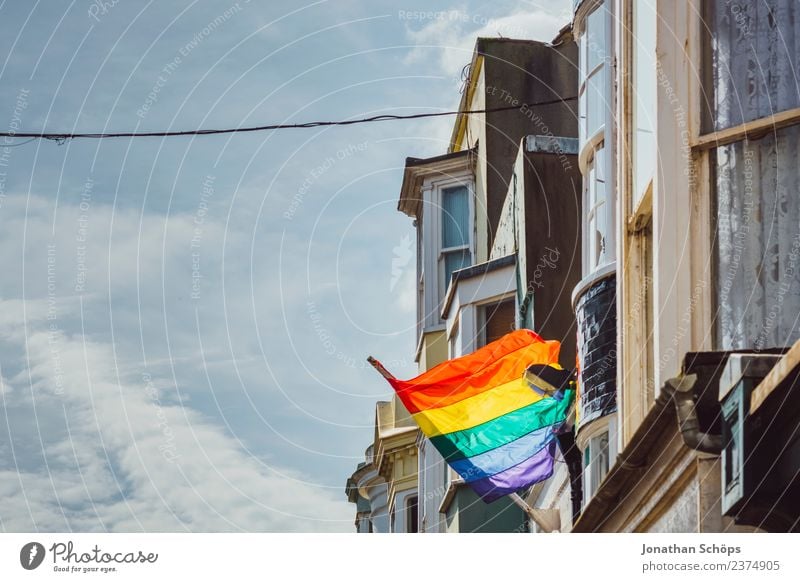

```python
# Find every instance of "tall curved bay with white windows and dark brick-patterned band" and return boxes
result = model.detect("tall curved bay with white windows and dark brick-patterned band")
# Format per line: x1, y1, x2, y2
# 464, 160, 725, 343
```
572, 0, 617, 501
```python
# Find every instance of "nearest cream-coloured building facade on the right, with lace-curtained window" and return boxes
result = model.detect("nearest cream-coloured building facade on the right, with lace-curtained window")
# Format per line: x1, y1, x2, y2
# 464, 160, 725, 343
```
552, 0, 800, 532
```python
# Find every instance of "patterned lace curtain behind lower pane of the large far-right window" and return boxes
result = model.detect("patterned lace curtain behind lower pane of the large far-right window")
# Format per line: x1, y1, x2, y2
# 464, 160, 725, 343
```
716, 126, 800, 349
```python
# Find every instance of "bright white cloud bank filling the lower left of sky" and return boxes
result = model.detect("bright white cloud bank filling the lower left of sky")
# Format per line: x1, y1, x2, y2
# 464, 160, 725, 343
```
0, 310, 352, 531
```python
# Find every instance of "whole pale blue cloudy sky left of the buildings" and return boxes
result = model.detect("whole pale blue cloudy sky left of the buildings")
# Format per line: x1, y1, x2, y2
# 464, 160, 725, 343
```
0, 0, 570, 531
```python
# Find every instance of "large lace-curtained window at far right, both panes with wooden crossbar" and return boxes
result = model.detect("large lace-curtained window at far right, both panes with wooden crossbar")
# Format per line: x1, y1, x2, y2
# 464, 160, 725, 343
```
697, 0, 800, 350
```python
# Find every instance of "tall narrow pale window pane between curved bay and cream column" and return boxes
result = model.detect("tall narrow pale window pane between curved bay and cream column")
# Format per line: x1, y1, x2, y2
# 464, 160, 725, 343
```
631, 0, 657, 209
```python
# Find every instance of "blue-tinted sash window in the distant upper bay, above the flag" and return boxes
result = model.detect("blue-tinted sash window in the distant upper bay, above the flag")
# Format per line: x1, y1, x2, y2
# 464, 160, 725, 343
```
439, 186, 472, 305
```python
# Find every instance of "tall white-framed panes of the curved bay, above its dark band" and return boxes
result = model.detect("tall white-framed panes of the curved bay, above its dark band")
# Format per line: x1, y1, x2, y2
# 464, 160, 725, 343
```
578, 3, 614, 275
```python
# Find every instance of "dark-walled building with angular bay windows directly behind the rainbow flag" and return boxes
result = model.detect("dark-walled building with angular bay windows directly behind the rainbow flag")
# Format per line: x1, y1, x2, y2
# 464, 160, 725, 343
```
346, 31, 581, 533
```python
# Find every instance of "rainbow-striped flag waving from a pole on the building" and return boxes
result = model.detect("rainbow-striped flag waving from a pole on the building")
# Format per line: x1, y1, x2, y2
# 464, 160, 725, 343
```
370, 330, 575, 502
